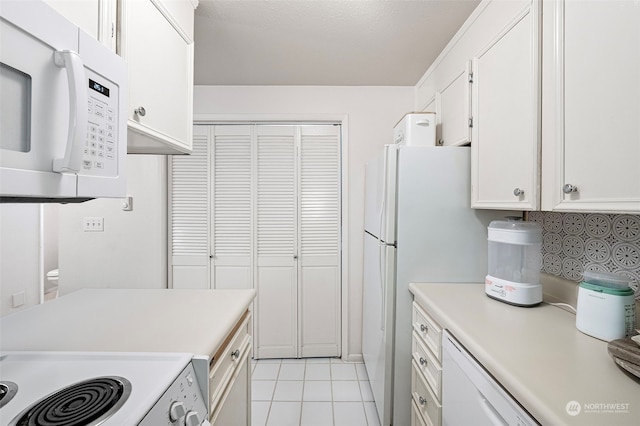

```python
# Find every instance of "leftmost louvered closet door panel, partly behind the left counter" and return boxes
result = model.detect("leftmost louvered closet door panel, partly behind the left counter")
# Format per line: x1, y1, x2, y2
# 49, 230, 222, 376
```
169, 126, 210, 288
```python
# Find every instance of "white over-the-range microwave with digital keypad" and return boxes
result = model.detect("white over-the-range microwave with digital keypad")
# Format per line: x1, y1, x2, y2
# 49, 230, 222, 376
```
0, 0, 127, 202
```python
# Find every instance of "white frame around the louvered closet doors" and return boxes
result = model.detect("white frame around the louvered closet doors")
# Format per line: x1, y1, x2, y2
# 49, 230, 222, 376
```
193, 113, 350, 361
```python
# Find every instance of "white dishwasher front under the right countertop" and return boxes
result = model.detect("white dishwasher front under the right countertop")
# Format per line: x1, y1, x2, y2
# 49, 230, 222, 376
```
442, 330, 538, 426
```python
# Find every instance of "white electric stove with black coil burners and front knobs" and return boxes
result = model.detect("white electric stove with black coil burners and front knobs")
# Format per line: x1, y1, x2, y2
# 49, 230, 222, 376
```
0, 352, 210, 426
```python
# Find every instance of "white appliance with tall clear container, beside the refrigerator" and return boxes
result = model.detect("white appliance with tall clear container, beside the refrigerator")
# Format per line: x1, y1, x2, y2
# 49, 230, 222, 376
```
484, 220, 542, 306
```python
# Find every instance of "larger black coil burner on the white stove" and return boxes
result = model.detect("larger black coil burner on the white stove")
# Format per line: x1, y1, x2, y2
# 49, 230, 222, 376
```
11, 376, 131, 426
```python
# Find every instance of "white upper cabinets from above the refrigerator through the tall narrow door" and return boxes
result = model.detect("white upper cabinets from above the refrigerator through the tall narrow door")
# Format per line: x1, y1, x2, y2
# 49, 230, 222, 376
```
416, 0, 541, 210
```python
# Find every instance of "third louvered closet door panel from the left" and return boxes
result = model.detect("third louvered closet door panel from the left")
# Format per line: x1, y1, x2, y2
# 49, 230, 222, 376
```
255, 126, 298, 358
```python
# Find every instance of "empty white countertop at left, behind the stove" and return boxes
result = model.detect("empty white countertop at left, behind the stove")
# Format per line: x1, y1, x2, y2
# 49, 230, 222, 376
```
0, 289, 255, 358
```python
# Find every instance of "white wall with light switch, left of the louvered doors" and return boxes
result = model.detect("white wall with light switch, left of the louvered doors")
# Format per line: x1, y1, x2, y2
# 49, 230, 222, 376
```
59, 155, 167, 295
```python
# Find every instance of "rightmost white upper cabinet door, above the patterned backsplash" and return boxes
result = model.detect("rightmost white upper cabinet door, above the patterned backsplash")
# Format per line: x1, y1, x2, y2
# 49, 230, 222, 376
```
543, 0, 640, 213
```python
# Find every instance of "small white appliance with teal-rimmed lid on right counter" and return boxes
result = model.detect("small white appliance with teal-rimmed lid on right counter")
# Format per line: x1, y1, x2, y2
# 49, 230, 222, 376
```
576, 271, 636, 342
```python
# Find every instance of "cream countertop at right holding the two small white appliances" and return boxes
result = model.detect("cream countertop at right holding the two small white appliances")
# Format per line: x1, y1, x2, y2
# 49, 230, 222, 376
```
410, 283, 640, 426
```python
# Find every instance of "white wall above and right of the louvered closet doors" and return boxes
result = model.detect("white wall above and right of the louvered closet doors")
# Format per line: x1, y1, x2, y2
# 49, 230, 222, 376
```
194, 86, 414, 359
